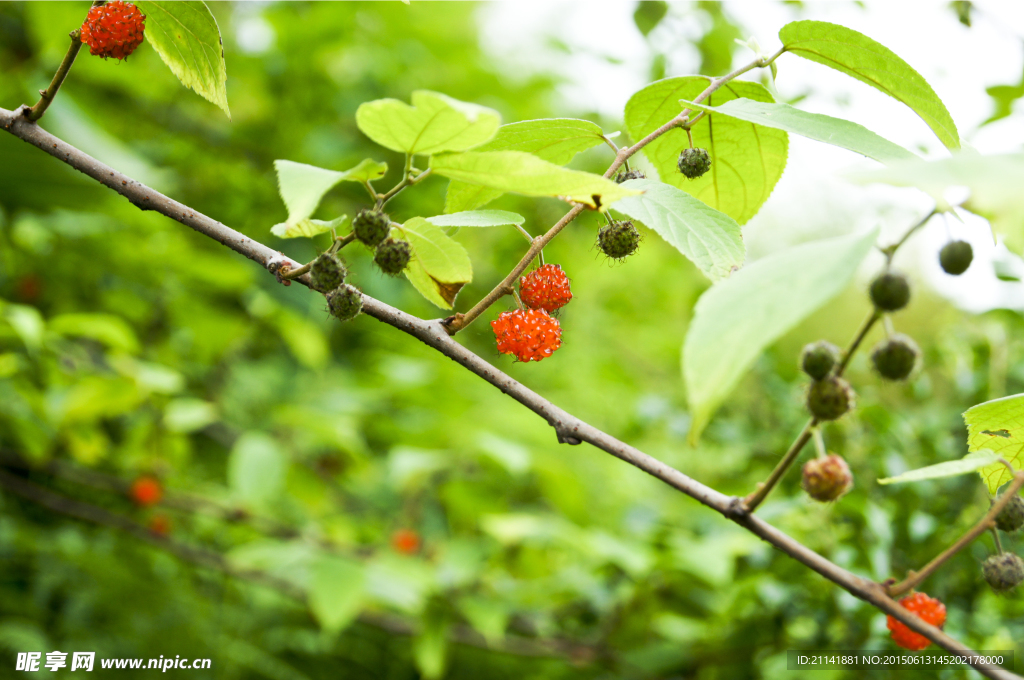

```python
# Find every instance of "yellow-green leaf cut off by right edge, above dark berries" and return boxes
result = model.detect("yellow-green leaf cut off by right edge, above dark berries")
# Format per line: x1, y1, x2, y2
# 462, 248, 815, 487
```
964, 394, 1024, 494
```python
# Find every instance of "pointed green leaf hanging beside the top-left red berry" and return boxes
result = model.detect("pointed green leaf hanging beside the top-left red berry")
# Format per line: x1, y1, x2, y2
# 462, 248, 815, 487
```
135, 0, 231, 118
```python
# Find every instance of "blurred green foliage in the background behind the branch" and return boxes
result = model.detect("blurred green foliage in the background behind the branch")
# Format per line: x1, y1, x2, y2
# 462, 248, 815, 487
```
0, 2, 1024, 680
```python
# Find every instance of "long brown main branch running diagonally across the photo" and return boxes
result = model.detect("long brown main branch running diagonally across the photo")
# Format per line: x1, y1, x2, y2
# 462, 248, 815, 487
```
0, 109, 1024, 680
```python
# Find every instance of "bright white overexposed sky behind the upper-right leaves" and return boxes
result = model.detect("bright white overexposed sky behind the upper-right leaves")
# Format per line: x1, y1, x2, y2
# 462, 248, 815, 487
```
480, 0, 1024, 311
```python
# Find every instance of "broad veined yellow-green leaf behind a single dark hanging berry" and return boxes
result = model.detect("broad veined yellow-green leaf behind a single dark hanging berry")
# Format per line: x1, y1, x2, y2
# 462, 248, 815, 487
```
626, 76, 790, 224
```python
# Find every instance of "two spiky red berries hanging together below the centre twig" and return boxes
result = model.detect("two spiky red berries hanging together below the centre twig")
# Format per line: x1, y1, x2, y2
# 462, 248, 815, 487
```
490, 264, 572, 362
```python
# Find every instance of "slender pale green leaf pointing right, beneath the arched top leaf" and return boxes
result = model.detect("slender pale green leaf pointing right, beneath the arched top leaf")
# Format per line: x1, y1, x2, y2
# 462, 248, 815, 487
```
679, 98, 918, 163
